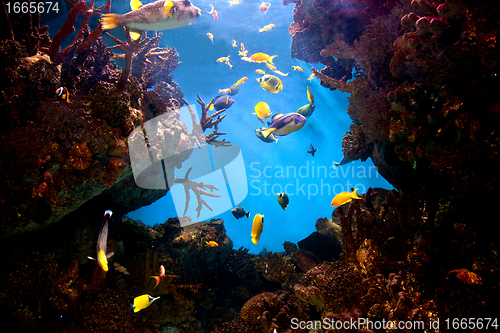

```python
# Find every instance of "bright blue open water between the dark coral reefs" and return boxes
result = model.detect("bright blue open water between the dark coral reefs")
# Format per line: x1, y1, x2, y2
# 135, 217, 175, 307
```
47, 0, 392, 253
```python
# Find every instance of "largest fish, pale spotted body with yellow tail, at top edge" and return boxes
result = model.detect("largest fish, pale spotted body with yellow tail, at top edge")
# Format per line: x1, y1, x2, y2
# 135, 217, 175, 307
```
99, 0, 201, 40
